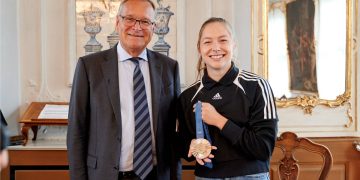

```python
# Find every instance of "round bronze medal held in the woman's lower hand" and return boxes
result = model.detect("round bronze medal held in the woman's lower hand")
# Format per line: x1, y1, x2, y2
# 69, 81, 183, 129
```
190, 139, 211, 159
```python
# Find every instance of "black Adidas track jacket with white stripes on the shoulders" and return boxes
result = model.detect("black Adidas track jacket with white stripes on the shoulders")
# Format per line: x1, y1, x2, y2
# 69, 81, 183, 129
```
178, 65, 278, 178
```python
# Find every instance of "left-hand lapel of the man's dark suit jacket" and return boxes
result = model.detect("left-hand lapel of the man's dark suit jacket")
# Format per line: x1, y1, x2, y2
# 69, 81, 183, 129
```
101, 45, 121, 127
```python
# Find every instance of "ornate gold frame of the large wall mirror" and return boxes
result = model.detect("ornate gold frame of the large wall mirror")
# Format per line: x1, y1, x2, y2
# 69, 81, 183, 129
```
252, 0, 358, 114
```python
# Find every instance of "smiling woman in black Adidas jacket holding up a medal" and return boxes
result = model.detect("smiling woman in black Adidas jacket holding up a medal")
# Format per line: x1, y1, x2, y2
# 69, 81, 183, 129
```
178, 18, 278, 180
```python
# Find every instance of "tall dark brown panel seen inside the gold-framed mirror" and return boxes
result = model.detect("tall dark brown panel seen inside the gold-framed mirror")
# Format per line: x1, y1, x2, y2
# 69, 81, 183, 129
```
286, 0, 318, 95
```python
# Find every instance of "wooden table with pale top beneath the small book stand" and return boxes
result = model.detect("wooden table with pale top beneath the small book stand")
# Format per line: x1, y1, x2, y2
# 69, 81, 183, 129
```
0, 139, 70, 180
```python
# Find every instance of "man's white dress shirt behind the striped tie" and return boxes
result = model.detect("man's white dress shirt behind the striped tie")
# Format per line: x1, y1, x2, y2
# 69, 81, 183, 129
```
117, 43, 156, 171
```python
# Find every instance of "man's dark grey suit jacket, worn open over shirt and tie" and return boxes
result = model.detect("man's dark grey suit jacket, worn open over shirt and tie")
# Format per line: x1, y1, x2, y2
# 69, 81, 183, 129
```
67, 46, 181, 180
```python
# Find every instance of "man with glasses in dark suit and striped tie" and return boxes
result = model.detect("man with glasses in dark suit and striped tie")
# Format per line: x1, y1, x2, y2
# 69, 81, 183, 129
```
67, 0, 181, 180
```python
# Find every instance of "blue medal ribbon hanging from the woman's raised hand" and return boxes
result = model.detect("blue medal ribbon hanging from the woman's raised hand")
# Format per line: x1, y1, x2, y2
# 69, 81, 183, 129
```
195, 101, 213, 169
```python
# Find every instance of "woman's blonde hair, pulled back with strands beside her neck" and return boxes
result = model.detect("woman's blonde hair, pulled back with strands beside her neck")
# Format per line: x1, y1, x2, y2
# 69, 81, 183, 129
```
196, 17, 236, 80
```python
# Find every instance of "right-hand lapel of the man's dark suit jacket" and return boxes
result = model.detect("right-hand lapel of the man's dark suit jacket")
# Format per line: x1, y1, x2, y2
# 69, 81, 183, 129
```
147, 50, 162, 134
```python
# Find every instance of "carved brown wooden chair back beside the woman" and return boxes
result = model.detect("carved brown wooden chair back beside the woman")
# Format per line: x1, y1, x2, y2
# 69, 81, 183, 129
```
275, 132, 333, 180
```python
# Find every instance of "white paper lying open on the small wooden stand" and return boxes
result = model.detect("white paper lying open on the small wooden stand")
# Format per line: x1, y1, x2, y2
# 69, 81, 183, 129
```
38, 104, 69, 119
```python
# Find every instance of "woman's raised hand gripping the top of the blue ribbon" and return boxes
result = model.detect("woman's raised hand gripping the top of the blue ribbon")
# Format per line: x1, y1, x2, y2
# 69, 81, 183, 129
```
194, 102, 228, 130
